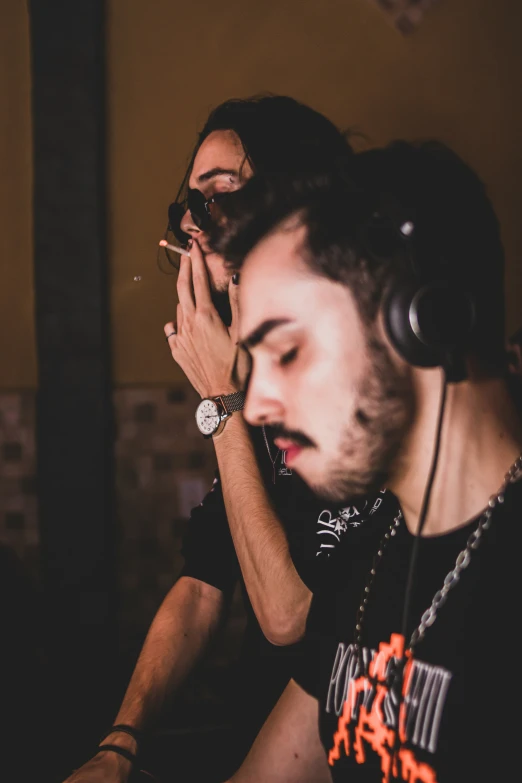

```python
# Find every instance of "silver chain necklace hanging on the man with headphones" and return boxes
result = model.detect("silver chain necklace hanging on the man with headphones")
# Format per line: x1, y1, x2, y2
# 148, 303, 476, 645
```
354, 454, 522, 650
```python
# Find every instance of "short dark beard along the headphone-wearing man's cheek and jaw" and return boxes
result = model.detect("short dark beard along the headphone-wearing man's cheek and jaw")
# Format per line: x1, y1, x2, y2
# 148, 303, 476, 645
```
315, 338, 414, 503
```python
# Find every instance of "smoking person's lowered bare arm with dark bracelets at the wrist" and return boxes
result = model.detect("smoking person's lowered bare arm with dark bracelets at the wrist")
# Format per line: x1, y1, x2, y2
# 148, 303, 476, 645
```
62, 577, 225, 783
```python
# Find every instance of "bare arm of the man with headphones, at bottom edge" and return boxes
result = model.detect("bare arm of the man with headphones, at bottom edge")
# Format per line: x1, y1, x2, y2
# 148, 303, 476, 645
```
223, 680, 332, 783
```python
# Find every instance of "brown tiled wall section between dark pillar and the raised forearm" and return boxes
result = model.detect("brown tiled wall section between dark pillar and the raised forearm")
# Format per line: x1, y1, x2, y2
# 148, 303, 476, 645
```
114, 386, 223, 648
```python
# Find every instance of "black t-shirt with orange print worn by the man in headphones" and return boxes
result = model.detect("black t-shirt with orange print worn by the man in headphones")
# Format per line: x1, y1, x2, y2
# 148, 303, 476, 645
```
294, 474, 522, 783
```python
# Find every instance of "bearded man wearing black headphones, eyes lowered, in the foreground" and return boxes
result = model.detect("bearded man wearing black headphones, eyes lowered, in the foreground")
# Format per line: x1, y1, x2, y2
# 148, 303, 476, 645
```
214, 142, 522, 783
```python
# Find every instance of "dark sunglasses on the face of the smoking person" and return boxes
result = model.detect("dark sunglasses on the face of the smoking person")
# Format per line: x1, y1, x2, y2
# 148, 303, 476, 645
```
158, 188, 229, 274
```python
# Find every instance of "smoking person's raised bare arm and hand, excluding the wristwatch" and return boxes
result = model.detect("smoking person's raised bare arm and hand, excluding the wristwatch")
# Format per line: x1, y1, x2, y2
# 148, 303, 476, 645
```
165, 242, 311, 645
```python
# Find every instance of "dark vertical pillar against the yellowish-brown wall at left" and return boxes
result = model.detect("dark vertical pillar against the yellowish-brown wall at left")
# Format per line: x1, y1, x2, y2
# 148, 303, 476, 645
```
29, 0, 117, 766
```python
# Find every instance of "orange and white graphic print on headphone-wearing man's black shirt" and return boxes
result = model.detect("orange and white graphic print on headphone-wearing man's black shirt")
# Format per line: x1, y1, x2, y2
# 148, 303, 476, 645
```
325, 634, 451, 783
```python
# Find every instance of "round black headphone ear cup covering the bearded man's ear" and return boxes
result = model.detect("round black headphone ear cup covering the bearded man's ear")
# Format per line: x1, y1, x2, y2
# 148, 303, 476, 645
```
384, 281, 475, 367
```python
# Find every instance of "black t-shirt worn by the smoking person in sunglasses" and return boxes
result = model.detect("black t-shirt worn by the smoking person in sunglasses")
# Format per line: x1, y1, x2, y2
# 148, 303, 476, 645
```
182, 429, 397, 736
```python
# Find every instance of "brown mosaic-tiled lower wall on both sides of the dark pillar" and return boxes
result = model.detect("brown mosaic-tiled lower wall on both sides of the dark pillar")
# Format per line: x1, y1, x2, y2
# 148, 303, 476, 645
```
0, 385, 244, 724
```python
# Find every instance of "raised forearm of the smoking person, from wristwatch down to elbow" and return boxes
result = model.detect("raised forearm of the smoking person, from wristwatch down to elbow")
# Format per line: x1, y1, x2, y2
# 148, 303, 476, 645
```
214, 413, 311, 644
